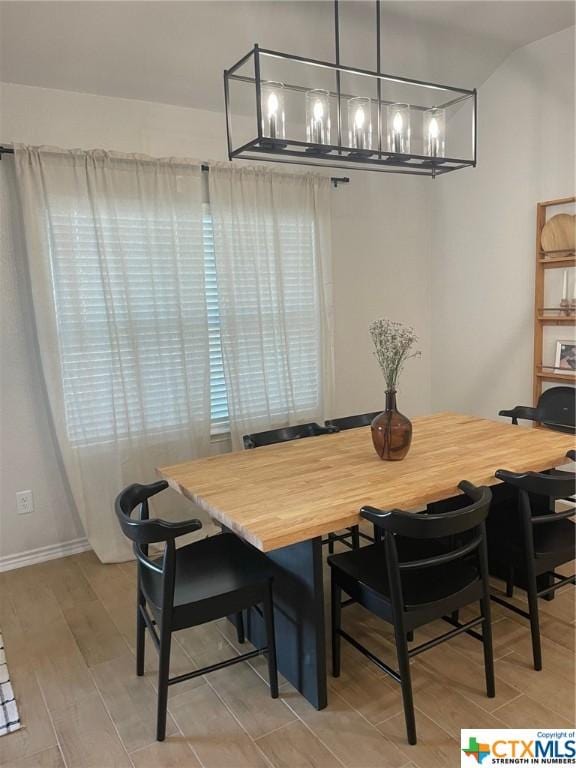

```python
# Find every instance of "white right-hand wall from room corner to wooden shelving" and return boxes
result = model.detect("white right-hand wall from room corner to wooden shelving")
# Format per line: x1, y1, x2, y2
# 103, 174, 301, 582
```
432, 28, 576, 417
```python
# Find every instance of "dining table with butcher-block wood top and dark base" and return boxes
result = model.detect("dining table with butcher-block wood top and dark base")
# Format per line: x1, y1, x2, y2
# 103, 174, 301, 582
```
158, 412, 574, 709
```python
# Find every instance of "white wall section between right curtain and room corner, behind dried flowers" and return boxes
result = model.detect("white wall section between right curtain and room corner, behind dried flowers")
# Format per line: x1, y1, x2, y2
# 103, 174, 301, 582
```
333, 172, 433, 416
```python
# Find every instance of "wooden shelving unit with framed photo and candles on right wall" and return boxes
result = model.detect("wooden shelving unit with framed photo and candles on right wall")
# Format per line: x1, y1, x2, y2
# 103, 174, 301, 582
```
534, 197, 576, 405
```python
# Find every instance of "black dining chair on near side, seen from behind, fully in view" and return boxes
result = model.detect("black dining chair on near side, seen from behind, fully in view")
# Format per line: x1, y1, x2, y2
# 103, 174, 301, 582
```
328, 481, 495, 744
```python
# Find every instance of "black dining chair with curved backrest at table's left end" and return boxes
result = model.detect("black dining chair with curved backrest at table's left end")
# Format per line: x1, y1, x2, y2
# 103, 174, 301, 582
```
115, 480, 278, 741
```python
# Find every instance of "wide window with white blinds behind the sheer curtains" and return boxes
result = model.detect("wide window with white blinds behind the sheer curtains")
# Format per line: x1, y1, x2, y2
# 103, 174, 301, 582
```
44, 170, 325, 446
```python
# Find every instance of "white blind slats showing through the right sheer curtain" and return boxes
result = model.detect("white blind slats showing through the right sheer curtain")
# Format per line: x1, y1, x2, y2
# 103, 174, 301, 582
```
221, 212, 322, 423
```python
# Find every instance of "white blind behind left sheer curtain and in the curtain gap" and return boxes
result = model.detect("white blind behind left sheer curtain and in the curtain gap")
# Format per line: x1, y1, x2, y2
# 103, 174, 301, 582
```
50, 204, 228, 443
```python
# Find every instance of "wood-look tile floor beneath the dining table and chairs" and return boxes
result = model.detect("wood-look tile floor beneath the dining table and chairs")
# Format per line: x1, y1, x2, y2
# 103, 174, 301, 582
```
0, 552, 576, 768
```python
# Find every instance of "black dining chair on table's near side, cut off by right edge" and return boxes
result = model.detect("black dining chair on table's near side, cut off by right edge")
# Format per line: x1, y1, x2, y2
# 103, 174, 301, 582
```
490, 460, 576, 670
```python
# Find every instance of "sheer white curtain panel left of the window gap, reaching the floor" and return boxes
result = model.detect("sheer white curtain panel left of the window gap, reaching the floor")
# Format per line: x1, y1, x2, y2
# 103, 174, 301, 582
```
15, 147, 210, 562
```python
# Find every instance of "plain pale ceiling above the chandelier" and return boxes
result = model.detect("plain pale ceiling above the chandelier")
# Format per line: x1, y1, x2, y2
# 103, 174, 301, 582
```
0, 0, 574, 110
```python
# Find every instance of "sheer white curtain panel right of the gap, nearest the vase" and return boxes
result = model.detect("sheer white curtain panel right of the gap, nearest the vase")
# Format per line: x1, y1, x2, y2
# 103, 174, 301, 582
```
209, 165, 333, 448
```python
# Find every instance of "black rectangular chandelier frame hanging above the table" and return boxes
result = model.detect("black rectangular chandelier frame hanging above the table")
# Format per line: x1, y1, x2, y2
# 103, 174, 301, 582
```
224, 0, 478, 178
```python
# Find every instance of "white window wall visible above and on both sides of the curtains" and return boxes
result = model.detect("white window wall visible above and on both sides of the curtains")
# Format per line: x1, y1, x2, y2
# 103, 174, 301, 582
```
0, 84, 432, 557
